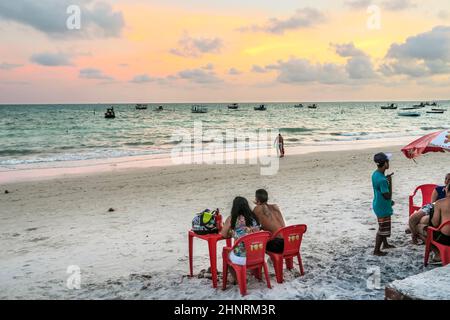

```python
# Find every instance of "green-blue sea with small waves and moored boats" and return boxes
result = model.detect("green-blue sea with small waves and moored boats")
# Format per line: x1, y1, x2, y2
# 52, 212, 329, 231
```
0, 101, 450, 168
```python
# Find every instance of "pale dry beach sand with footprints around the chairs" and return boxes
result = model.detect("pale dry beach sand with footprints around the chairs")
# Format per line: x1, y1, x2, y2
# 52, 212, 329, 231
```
0, 146, 449, 299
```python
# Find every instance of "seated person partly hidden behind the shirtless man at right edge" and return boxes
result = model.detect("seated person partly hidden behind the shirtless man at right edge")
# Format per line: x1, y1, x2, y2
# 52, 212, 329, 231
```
409, 173, 450, 244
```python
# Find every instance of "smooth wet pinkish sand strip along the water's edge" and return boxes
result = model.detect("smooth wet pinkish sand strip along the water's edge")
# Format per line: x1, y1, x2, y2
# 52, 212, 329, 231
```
0, 136, 418, 185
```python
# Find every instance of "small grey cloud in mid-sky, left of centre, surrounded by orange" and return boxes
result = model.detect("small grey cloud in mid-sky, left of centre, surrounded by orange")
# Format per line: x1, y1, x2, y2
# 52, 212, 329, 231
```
170, 33, 223, 58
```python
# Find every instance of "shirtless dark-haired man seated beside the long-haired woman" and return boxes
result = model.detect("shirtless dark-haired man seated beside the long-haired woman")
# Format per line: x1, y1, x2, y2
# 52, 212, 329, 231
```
253, 189, 286, 253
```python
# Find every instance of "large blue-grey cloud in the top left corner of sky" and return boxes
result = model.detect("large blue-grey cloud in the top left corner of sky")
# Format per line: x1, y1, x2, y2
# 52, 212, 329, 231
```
0, 0, 125, 38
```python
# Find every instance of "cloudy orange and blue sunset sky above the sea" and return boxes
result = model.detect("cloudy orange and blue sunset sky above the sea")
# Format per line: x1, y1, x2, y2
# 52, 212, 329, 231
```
0, 0, 450, 104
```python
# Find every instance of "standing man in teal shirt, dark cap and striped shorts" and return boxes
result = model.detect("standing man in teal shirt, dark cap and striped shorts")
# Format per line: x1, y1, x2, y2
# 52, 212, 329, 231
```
372, 152, 395, 256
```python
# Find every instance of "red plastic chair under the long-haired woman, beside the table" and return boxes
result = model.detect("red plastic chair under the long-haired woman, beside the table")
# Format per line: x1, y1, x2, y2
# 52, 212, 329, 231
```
222, 231, 272, 296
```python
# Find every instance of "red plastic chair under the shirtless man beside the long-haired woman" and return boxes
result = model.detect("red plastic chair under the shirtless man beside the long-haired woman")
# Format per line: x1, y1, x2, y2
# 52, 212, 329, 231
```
267, 224, 307, 283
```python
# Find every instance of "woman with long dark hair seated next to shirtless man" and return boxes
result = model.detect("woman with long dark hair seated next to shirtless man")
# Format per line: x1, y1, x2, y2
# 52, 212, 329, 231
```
221, 197, 260, 264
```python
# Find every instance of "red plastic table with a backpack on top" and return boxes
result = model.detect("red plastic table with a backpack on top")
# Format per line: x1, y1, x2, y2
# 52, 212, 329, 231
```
188, 230, 231, 288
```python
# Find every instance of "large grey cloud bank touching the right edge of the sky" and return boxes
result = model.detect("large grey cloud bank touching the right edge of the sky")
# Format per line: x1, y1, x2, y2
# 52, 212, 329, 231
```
380, 26, 450, 77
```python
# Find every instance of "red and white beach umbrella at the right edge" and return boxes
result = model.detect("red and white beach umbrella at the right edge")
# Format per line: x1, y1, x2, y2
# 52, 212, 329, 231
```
402, 130, 450, 159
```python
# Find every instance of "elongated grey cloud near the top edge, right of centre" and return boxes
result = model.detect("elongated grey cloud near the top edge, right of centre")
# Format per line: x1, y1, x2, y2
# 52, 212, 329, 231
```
239, 8, 326, 35
